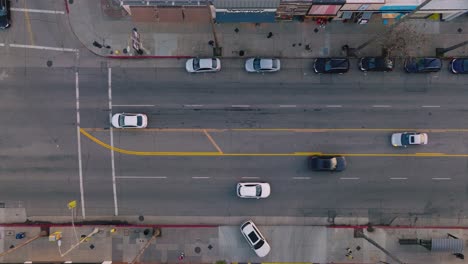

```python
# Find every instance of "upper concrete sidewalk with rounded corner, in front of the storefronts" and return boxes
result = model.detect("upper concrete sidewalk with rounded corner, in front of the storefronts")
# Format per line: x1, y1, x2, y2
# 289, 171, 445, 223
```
67, 0, 468, 58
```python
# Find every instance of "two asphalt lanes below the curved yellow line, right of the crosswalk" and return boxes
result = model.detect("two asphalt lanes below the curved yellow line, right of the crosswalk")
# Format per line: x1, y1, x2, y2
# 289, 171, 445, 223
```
113, 157, 467, 216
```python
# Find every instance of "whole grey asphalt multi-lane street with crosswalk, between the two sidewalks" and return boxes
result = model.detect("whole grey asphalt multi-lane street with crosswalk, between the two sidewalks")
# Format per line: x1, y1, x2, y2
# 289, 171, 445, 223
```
0, 0, 468, 223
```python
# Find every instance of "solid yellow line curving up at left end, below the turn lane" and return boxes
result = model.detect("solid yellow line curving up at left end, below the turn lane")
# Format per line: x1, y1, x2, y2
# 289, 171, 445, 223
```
80, 128, 468, 157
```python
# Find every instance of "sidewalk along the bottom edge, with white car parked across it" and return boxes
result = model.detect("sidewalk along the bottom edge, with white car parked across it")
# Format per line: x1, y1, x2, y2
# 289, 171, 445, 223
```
0, 225, 468, 264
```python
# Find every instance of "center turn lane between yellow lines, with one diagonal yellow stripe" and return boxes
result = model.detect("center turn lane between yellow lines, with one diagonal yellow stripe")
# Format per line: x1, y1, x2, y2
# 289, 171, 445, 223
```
83, 129, 468, 156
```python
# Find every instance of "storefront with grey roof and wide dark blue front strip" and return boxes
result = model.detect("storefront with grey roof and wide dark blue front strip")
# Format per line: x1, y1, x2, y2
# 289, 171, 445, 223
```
212, 0, 280, 23
